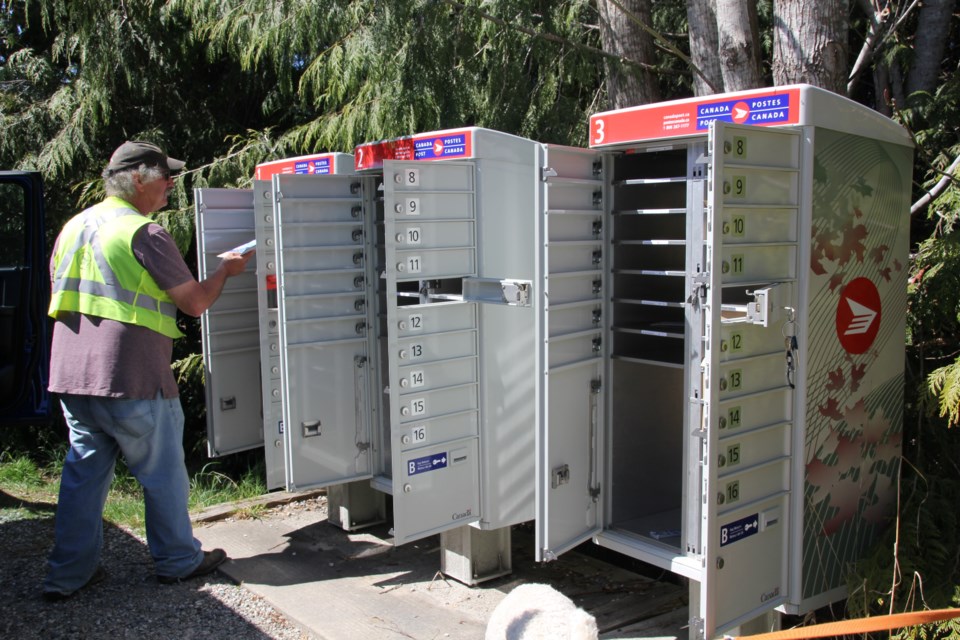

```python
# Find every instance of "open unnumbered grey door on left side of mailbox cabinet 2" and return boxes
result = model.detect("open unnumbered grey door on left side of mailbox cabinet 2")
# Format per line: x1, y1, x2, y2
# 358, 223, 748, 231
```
273, 174, 375, 491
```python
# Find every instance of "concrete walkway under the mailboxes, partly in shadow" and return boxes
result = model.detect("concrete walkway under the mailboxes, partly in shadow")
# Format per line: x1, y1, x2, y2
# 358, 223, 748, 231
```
195, 494, 687, 640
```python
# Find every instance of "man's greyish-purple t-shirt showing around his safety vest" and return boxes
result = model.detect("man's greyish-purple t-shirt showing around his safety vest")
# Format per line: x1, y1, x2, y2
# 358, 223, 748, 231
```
49, 223, 193, 399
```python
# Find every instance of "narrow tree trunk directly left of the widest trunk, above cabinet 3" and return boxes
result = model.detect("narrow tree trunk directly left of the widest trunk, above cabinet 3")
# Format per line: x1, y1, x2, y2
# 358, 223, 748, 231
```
716, 0, 762, 91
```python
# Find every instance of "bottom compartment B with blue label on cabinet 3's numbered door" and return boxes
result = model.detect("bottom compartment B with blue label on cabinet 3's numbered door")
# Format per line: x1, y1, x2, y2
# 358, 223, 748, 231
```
710, 496, 790, 620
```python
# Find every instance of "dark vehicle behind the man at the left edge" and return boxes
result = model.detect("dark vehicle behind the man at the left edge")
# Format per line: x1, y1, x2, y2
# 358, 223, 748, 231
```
0, 171, 51, 424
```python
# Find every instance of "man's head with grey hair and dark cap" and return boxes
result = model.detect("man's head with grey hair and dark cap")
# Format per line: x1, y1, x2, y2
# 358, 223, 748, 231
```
103, 141, 184, 214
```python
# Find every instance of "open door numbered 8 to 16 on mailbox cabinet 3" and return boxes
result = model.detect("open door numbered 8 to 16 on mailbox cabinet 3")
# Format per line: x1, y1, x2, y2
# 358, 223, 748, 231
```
689, 121, 802, 638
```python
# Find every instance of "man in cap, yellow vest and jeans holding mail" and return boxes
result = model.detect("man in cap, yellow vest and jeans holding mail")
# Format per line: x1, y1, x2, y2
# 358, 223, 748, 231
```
43, 142, 253, 601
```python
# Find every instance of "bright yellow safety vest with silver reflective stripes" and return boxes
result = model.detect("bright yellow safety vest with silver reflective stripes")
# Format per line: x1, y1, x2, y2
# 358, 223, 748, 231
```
49, 196, 184, 338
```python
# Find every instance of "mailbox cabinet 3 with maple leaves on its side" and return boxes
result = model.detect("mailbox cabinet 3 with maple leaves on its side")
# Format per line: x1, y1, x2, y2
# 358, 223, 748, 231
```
537, 85, 912, 638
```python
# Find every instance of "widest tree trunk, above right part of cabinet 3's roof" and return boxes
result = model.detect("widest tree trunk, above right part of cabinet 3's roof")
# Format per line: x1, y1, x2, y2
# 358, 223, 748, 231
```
773, 0, 849, 95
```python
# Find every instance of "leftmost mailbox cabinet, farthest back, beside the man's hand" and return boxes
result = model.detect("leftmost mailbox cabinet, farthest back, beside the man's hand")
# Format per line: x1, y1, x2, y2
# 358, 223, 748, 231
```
195, 153, 353, 489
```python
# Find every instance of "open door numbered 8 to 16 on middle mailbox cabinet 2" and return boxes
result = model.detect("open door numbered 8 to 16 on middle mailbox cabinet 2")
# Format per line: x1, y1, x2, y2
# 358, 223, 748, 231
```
383, 160, 481, 544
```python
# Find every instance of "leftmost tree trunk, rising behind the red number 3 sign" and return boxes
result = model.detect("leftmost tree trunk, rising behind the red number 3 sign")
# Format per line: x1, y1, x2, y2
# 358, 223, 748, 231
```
597, 0, 660, 109
